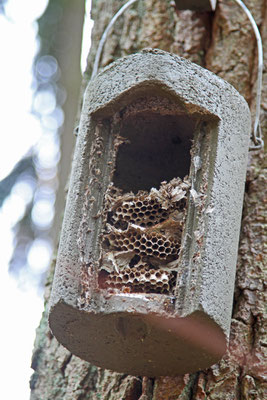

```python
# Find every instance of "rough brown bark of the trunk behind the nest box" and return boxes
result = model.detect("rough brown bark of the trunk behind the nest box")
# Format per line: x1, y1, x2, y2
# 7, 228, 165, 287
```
31, 0, 267, 400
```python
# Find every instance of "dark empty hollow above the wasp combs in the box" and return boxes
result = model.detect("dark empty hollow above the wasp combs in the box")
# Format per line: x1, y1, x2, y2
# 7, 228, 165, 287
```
113, 111, 194, 193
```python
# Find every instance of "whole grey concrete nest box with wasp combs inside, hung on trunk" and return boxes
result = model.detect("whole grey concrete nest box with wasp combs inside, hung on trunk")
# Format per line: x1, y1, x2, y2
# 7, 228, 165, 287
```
49, 49, 250, 377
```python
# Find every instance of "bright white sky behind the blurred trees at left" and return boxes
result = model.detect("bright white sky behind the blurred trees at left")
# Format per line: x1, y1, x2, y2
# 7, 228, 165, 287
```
0, 0, 92, 400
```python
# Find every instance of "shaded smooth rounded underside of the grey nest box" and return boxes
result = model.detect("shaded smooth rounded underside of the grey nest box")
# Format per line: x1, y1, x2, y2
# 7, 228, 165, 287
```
50, 303, 226, 377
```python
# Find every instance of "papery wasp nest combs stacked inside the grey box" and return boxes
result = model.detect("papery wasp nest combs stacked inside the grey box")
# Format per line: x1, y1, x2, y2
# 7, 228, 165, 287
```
99, 178, 189, 293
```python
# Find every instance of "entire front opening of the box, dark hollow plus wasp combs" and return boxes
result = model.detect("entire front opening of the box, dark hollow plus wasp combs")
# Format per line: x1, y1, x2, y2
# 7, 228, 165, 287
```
98, 95, 199, 294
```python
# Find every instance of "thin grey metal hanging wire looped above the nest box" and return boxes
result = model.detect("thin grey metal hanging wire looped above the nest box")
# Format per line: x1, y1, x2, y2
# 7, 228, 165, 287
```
91, 0, 264, 150
